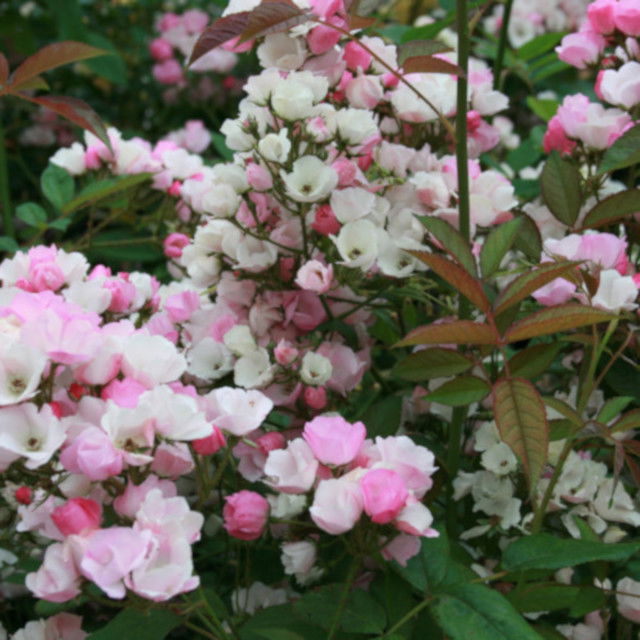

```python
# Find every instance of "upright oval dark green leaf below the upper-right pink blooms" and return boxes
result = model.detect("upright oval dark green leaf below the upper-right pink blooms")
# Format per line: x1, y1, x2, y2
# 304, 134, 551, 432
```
540, 151, 582, 226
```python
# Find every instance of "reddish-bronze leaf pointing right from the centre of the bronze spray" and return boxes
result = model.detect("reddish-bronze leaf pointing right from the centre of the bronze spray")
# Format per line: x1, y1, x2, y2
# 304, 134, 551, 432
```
504, 304, 617, 342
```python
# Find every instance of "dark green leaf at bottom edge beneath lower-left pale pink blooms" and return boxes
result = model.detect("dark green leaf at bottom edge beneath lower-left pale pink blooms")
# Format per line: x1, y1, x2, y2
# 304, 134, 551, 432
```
87, 609, 181, 640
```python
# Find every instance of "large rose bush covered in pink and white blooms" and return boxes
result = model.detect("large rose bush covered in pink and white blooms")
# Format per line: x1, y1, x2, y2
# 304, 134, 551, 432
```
0, 0, 640, 640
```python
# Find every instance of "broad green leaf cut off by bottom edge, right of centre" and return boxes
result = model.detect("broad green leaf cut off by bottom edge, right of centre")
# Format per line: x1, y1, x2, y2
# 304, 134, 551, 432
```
431, 583, 540, 640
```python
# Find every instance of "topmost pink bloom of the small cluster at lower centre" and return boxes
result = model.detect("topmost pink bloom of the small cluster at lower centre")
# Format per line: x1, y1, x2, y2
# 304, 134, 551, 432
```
302, 416, 367, 465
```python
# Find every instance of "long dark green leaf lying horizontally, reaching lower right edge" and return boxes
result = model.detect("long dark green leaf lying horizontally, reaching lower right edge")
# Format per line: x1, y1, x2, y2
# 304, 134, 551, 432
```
502, 533, 640, 571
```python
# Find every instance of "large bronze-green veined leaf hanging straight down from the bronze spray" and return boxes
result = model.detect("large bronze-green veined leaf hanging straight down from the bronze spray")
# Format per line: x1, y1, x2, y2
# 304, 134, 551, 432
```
493, 378, 549, 492
